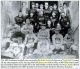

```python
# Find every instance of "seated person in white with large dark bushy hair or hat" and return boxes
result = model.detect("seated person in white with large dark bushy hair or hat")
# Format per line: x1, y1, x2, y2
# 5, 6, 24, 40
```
4, 32, 25, 59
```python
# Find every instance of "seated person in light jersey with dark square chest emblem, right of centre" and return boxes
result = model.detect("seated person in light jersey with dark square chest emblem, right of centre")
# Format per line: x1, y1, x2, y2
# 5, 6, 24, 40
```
52, 25, 64, 54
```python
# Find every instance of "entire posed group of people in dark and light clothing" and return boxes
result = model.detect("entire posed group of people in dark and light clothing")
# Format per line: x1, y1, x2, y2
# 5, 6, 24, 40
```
1, 2, 77, 58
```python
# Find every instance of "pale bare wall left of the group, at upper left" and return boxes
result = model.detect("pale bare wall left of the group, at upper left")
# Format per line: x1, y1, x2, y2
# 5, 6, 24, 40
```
1, 1, 20, 37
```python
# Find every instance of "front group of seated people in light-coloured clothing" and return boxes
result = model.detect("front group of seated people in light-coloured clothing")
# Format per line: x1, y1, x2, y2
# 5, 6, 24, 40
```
4, 19, 77, 59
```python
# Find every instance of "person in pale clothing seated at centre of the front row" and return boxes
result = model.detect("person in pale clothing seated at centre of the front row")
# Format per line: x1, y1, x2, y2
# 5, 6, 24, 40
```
34, 25, 51, 56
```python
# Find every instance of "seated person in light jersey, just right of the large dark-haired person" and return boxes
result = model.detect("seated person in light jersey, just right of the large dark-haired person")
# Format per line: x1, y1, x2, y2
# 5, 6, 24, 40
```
24, 31, 37, 58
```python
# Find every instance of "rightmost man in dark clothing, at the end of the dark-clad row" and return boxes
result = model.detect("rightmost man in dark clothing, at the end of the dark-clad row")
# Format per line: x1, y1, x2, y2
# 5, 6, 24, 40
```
60, 12, 70, 37
